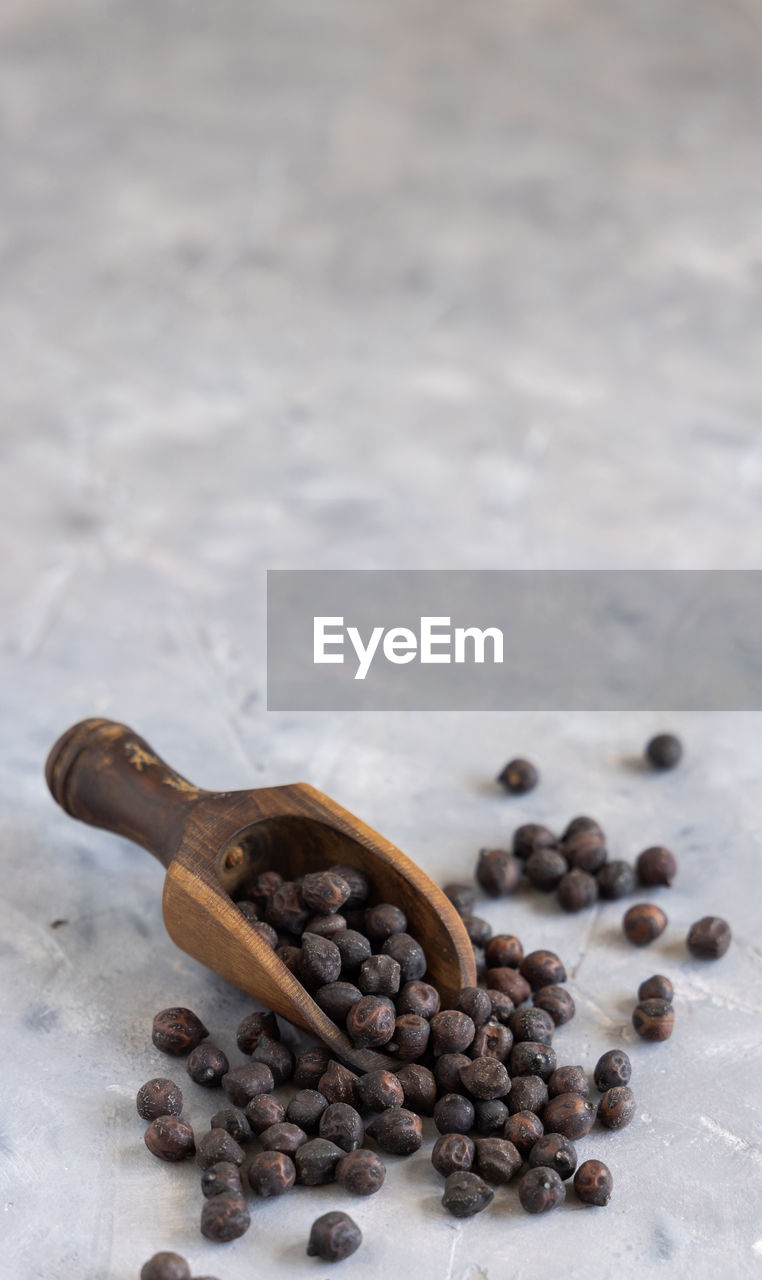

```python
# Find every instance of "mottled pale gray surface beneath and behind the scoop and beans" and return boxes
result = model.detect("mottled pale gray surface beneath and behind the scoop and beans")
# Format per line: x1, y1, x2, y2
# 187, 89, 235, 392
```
0, 0, 762, 1280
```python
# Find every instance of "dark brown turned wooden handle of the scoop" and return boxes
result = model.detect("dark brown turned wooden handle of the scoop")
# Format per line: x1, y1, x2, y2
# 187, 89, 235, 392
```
45, 718, 209, 867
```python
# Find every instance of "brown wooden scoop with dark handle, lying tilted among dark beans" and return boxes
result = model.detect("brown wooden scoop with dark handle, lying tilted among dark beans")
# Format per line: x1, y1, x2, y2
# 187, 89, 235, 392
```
45, 719, 476, 1071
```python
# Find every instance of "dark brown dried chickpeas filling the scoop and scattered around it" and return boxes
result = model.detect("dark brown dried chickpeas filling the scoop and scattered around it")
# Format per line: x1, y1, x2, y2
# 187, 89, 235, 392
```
137, 751, 730, 1264
